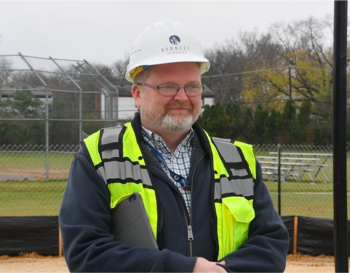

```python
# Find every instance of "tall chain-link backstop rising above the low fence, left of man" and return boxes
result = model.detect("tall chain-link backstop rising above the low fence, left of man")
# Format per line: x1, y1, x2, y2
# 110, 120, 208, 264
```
0, 53, 123, 147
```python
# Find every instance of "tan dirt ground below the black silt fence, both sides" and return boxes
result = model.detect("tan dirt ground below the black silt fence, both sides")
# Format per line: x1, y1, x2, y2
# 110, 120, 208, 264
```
0, 253, 346, 273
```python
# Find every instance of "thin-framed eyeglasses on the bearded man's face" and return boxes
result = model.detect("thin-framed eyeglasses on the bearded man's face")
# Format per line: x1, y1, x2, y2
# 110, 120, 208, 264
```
136, 82, 204, 97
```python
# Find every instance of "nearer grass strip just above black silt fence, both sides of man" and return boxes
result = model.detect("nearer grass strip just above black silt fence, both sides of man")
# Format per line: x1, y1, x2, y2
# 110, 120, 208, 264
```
0, 180, 344, 219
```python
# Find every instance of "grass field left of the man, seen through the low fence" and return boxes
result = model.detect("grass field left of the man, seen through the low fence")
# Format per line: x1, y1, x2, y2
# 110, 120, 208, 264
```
0, 152, 74, 216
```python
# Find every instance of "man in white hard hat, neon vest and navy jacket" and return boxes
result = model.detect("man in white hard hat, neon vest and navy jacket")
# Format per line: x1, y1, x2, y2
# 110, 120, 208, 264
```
59, 20, 288, 272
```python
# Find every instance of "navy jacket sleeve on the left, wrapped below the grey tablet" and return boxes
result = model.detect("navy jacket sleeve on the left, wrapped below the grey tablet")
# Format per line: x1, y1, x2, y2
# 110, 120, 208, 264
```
59, 149, 196, 272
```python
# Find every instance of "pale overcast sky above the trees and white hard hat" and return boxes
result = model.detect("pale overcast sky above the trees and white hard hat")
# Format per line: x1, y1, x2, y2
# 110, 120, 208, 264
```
0, 0, 334, 65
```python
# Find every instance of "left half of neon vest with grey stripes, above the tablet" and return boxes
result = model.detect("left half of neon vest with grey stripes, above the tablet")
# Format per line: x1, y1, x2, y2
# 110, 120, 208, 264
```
84, 123, 158, 238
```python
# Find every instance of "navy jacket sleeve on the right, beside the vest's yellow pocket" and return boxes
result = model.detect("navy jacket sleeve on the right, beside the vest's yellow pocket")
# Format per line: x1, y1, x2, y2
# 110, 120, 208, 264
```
222, 162, 289, 272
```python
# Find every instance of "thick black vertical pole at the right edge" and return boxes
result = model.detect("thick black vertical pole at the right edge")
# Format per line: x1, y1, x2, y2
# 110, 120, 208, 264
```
333, 1, 349, 272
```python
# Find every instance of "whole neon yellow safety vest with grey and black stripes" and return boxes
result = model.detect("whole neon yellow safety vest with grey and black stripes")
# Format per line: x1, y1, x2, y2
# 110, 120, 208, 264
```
84, 123, 256, 260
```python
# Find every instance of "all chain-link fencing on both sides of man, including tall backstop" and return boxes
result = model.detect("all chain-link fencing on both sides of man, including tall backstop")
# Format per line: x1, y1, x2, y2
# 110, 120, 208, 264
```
0, 53, 349, 219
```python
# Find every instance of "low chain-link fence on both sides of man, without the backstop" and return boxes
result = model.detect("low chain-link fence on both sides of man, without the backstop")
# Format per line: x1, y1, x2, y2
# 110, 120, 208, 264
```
0, 141, 349, 219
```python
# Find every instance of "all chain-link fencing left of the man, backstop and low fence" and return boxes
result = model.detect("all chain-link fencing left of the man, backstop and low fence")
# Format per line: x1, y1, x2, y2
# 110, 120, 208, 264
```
0, 53, 117, 216
